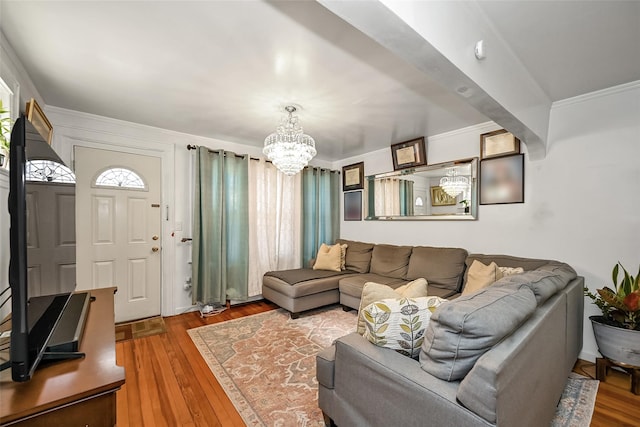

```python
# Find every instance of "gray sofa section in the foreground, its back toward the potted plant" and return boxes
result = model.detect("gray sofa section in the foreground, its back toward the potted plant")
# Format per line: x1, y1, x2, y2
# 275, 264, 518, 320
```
317, 255, 584, 427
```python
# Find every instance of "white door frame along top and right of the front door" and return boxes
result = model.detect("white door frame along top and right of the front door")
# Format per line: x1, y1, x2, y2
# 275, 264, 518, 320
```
54, 134, 176, 316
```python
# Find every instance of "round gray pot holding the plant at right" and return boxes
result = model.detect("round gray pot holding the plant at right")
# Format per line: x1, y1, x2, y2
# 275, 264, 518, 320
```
589, 316, 640, 366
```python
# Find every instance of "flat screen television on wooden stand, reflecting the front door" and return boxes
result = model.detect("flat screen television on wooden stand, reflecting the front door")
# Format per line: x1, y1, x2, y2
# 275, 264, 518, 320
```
1, 116, 89, 381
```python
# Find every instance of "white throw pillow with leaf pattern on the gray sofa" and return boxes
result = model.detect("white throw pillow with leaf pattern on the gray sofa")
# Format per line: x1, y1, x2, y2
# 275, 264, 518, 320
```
363, 297, 447, 359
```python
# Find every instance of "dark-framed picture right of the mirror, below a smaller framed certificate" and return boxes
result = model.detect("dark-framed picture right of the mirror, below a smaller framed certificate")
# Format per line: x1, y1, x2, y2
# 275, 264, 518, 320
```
480, 154, 524, 205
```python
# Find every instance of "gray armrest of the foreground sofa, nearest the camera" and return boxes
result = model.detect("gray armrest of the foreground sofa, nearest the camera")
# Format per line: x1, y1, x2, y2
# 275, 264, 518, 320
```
328, 333, 489, 426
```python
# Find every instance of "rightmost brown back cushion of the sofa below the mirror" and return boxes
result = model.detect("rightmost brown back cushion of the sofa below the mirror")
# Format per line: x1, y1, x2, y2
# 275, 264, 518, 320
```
406, 246, 467, 291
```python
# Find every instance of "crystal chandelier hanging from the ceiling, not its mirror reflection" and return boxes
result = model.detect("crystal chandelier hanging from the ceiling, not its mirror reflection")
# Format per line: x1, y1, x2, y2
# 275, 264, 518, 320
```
262, 105, 316, 175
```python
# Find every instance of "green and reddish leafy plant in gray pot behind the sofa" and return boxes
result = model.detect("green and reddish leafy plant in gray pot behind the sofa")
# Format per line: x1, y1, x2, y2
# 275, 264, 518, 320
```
584, 263, 640, 366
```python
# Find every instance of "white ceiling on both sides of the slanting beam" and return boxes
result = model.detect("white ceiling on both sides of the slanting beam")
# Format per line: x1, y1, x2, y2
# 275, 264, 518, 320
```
0, 0, 640, 160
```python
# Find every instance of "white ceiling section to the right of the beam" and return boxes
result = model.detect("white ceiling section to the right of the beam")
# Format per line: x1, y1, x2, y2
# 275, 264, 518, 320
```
478, 1, 640, 101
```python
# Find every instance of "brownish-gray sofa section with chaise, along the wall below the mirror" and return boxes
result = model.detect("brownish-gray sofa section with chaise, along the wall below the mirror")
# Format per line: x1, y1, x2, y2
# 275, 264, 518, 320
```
262, 239, 467, 318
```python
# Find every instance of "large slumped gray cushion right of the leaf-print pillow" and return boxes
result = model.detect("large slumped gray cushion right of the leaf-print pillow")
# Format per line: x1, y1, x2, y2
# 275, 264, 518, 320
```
420, 286, 537, 381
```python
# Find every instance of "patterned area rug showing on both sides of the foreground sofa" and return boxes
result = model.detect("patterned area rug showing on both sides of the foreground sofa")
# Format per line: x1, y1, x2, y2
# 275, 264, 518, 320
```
188, 307, 598, 427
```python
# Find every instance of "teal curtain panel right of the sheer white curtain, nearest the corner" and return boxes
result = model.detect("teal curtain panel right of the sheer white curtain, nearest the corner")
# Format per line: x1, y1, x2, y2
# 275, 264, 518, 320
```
302, 167, 340, 267
